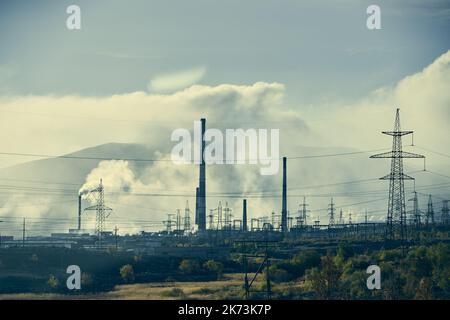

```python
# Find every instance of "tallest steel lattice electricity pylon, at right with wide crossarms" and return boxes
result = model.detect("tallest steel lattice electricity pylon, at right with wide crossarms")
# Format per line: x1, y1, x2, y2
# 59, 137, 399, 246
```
370, 109, 425, 240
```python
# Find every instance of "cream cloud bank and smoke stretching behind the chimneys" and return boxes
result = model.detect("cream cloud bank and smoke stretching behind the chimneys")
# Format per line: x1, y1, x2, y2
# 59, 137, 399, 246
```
0, 51, 450, 232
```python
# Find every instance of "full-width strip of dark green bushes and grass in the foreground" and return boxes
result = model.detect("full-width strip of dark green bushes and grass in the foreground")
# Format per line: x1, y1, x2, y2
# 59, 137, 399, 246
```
0, 242, 450, 300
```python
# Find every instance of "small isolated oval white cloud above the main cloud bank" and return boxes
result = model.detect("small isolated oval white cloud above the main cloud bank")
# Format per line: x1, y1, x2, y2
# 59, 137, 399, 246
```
148, 67, 206, 92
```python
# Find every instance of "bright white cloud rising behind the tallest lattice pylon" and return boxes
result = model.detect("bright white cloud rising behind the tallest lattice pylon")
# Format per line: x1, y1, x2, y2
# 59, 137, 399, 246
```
315, 51, 450, 165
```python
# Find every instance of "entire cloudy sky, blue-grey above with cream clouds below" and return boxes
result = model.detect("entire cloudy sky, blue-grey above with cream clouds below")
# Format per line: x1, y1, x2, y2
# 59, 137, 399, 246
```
0, 0, 450, 235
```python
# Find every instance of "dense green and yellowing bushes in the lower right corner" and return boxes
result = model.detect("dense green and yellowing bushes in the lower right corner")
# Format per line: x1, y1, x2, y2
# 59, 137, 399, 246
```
271, 244, 450, 299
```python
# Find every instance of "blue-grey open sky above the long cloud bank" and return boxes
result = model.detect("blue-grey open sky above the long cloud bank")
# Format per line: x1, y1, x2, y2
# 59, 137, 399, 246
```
0, 0, 450, 101
